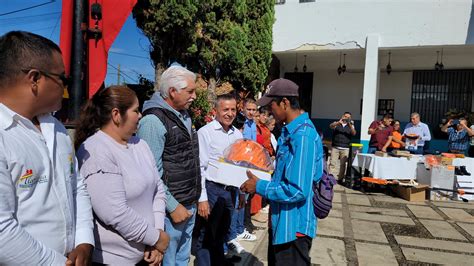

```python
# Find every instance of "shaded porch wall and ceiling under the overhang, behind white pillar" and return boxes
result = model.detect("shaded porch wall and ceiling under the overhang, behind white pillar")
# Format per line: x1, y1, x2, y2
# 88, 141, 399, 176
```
277, 45, 474, 121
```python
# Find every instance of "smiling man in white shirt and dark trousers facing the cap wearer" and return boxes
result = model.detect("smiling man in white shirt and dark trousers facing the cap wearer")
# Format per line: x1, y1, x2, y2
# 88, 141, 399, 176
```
194, 94, 244, 266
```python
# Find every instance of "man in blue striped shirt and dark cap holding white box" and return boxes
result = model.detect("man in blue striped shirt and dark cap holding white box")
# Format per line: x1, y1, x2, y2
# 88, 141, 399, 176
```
241, 79, 323, 265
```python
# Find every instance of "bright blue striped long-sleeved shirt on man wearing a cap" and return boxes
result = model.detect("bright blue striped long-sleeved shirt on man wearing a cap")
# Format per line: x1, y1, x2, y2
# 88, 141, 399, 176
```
257, 113, 323, 245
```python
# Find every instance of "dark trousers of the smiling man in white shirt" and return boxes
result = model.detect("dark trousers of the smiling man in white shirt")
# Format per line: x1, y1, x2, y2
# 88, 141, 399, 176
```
193, 181, 235, 266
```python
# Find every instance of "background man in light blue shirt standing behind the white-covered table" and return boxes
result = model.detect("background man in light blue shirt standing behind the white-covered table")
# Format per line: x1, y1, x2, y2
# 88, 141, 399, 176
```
403, 113, 431, 154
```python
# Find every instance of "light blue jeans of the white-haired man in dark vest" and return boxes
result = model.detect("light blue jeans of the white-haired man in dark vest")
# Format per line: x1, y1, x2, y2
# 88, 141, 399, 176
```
162, 204, 196, 266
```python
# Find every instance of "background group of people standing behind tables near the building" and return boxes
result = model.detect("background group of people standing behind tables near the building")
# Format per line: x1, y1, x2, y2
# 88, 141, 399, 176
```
329, 112, 474, 181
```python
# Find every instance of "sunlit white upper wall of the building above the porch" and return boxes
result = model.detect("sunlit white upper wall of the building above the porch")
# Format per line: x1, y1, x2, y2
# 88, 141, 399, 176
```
273, 0, 472, 51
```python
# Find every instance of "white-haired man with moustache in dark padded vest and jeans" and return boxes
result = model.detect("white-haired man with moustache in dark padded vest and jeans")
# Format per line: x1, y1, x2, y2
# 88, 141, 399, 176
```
137, 65, 201, 266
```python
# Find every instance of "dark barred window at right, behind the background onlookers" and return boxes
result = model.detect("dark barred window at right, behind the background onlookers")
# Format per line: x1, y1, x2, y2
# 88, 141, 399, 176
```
411, 69, 474, 138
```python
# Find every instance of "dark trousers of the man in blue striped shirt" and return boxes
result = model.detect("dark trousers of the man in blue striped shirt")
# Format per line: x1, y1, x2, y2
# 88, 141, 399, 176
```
267, 229, 312, 266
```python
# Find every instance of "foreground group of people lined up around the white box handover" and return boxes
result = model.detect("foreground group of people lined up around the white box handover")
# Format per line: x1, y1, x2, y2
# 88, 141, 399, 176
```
0, 31, 324, 265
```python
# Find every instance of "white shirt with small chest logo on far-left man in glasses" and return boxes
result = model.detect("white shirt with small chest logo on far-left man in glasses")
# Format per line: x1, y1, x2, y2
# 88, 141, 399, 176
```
0, 103, 94, 265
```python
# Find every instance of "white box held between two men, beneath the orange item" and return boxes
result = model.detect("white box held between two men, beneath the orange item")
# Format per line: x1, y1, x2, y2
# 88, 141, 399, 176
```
208, 161, 272, 187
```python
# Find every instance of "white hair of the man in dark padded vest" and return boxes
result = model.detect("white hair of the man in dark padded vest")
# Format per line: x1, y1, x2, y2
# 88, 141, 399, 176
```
158, 66, 196, 99
